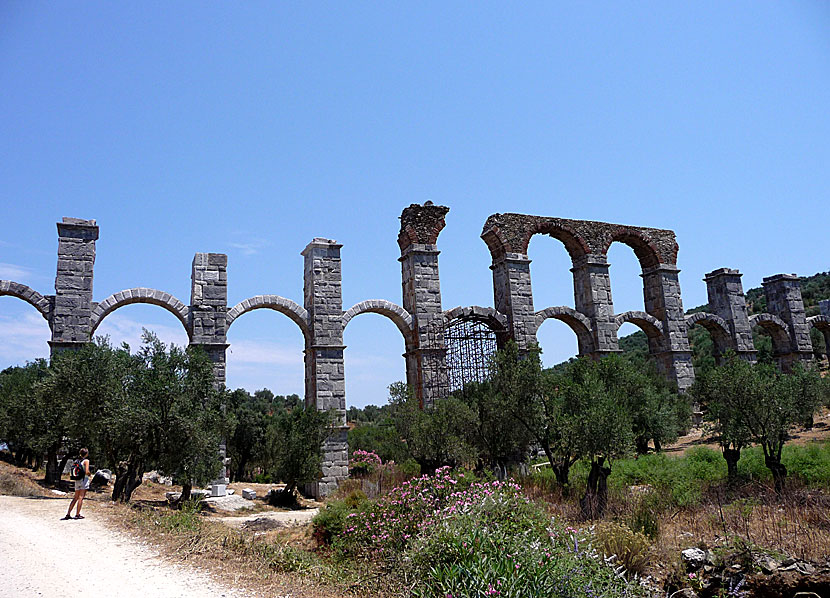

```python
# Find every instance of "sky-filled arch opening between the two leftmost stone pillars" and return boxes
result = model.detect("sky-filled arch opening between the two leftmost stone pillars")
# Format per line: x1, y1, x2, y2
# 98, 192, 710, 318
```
93, 303, 189, 353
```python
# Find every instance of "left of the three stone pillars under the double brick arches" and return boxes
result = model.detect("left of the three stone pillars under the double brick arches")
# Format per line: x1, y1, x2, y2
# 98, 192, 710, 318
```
490, 252, 540, 351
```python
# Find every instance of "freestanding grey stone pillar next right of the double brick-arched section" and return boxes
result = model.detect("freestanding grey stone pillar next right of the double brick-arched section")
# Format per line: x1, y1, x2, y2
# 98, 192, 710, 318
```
703, 268, 757, 363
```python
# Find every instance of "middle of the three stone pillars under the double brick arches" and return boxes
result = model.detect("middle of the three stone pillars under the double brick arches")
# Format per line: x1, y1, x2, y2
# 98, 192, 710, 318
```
571, 254, 620, 357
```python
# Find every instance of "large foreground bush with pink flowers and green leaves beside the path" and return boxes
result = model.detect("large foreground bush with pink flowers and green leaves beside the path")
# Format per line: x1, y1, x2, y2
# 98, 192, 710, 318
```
315, 468, 641, 598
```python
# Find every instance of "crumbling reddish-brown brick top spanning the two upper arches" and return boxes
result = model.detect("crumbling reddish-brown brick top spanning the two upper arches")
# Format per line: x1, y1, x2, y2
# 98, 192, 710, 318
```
481, 214, 678, 268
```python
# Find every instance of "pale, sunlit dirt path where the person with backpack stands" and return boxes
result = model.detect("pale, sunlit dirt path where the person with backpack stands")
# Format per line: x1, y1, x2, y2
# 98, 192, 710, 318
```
0, 496, 253, 598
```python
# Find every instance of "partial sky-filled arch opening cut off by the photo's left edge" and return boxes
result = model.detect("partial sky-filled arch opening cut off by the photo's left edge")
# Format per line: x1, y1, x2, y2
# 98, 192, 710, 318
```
0, 296, 52, 370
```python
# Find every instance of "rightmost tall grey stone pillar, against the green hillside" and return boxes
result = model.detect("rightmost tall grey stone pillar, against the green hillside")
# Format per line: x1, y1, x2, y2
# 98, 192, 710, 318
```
762, 274, 813, 372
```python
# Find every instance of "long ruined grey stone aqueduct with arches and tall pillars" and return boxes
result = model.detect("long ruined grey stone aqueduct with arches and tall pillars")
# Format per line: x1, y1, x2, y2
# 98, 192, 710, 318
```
0, 202, 830, 495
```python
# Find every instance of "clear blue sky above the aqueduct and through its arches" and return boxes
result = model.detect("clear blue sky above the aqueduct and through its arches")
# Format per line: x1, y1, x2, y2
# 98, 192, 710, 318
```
0, 2, 830, 406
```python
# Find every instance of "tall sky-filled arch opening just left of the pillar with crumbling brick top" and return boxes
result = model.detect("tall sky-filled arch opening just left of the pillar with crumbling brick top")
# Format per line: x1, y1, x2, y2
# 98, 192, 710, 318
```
343, 310, 406, 411
